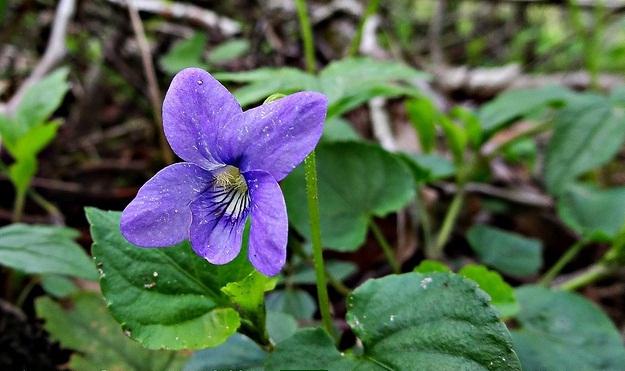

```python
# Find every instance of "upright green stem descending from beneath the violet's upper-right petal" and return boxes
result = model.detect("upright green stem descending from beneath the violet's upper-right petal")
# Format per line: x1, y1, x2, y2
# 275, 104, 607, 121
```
304, 151, 334, 334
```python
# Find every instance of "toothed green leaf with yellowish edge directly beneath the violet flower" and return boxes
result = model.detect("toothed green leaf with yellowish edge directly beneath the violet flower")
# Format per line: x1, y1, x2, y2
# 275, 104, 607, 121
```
86, 208, 253, 349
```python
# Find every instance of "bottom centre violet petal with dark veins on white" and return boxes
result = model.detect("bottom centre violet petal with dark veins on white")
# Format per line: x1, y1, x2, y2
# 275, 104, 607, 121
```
190, 189, 248, 264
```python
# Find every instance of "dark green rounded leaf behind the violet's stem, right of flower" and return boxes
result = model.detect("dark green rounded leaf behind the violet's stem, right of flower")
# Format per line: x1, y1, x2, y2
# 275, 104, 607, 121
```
282, 142, 415, 251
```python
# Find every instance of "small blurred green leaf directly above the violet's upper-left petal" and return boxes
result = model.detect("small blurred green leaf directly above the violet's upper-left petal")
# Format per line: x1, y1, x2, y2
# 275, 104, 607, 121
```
159, 32, 208, 75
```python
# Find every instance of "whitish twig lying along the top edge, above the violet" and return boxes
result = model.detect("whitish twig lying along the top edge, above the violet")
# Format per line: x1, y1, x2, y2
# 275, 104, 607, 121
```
108, 0, 241, 36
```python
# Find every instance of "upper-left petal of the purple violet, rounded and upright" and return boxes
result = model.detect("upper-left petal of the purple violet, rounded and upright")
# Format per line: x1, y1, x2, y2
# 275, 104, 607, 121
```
163, 68, 241, 170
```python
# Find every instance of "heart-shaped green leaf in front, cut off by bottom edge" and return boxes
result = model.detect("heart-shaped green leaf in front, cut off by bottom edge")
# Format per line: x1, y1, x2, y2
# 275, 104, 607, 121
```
265, 273, 520, 370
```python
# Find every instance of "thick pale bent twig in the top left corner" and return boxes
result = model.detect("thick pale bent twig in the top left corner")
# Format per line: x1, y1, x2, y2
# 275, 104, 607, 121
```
0, 0, 76, 115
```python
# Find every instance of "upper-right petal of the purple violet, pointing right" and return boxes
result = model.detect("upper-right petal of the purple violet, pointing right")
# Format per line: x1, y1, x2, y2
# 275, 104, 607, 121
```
218, 92, 328, 181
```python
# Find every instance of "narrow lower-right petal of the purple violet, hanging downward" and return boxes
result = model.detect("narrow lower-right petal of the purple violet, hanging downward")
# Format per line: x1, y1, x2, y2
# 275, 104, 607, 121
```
243, 171, 289, 276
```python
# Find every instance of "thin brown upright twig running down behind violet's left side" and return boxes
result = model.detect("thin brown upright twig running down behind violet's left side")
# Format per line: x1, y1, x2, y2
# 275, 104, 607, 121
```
126, 0, 174, 164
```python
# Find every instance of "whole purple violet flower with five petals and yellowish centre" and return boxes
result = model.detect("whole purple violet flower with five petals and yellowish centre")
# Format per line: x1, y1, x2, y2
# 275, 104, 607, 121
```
120, 68, 327, 276
